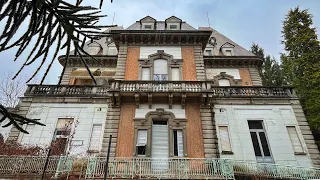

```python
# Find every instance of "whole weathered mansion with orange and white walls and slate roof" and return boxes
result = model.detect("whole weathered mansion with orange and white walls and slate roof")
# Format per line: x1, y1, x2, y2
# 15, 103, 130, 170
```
2, 16, 320, 179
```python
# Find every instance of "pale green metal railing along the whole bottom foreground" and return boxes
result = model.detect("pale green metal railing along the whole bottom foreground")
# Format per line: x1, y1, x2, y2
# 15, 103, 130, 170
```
0, 156, 320, 179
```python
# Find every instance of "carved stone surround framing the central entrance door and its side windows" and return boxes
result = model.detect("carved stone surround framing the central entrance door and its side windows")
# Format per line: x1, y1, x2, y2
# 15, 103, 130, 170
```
133, 108, 188, 157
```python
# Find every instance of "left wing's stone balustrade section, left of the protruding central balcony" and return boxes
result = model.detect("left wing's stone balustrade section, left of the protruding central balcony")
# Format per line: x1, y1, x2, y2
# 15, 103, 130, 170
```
24, 84, 109, 97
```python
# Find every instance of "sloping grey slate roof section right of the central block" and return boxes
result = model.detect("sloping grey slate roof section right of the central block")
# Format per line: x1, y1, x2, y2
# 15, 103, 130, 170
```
198, 27, 255, 56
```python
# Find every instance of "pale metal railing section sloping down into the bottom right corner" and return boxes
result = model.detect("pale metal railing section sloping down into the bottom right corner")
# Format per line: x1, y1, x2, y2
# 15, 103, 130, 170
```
233, 161, 320, 179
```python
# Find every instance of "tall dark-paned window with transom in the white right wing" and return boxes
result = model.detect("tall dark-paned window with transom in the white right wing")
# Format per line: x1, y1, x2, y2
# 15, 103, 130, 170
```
248, 121, 272, 162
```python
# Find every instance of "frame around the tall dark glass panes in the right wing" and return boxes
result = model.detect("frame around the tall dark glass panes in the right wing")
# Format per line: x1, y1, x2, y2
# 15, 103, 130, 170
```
247, 119, 274, 163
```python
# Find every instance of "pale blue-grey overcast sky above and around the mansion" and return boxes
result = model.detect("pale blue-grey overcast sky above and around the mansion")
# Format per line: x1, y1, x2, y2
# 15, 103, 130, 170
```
0, 0, 320, 84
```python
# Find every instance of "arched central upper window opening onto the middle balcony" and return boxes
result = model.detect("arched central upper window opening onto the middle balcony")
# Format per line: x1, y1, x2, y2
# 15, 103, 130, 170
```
153, 59, 168, 81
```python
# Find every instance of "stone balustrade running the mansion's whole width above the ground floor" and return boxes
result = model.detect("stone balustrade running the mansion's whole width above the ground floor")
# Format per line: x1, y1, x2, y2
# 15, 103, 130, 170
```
25, 81, 295, 98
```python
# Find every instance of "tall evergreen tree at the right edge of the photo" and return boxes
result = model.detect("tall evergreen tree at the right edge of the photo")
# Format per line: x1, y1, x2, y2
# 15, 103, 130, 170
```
282, 7, 320, 130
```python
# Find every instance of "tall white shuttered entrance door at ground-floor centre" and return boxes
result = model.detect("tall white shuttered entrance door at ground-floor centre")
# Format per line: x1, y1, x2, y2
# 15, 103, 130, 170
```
151, 121, 169, 172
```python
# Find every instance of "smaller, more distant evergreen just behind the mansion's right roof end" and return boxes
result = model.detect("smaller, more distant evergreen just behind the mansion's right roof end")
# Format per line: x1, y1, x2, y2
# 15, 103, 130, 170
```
251, 43, 284, 86
